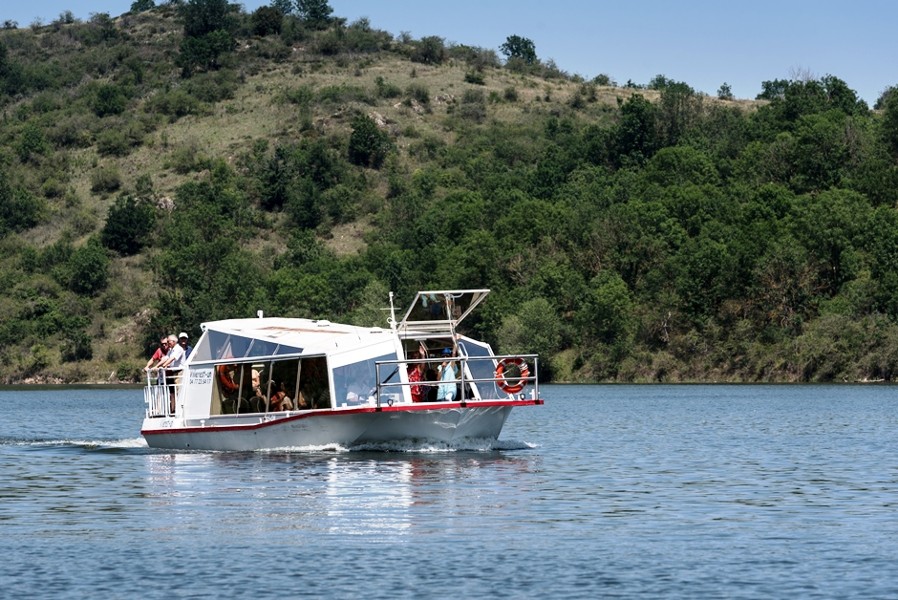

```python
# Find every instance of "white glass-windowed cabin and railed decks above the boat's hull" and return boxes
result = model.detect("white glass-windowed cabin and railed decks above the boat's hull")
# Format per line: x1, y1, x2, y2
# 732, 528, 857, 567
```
145, 290, 538, 424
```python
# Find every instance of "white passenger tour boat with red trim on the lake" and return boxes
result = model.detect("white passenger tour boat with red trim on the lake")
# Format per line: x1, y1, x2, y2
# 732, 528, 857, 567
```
141, 289, 544, 451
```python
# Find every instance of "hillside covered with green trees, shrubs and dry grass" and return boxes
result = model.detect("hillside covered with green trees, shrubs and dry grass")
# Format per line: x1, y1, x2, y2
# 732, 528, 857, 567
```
0, 0, 898, 383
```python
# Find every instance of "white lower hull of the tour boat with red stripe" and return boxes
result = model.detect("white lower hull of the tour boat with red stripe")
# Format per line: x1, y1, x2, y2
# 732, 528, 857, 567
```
141, 400, 542, 451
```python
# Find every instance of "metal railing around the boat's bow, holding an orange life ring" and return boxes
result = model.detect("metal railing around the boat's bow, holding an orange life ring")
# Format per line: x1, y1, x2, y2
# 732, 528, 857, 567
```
374, 354, 539, 406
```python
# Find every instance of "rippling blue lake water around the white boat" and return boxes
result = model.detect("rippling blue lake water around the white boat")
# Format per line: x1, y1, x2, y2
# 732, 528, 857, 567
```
0, 385, 898, 599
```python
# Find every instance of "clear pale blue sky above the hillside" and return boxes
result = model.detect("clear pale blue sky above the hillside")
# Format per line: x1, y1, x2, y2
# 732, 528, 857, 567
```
0, 0, 898, 106
